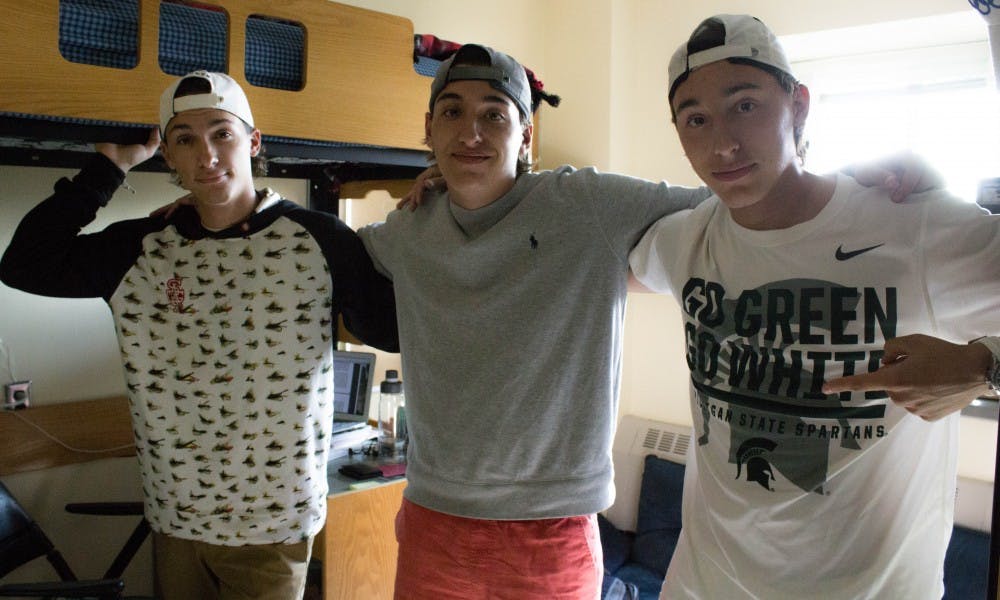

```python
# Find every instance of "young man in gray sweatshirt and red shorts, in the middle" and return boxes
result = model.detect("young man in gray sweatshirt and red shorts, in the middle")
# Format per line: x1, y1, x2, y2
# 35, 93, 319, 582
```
359, 45, 709, 600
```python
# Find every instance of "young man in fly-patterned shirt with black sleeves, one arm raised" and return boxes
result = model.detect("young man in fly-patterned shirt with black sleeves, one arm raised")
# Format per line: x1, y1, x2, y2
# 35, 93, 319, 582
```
0, 71, 398, 600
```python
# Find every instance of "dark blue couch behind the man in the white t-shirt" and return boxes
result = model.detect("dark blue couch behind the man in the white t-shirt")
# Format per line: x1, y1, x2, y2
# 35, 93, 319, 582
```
598, 455, 990, 600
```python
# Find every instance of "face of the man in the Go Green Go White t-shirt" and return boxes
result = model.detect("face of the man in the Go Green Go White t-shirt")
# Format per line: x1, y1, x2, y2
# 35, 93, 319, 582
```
672, 60, 809, 222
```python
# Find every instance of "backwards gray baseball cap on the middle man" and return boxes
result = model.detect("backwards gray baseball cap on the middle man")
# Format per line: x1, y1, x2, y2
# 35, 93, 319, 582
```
428, 44, 531, 118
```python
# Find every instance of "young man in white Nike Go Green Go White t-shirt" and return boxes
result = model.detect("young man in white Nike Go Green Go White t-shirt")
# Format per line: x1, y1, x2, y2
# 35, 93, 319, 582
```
630, 15, 1000, 600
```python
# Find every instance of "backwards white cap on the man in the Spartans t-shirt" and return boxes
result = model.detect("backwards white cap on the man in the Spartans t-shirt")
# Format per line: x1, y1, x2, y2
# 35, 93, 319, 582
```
668, 15, 792, 100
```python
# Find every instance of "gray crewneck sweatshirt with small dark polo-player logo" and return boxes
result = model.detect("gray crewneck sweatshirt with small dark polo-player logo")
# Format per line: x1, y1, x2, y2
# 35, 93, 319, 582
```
359, 167, 710, 519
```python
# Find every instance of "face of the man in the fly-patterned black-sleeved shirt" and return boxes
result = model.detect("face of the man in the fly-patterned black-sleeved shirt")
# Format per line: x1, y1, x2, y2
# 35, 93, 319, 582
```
161, 108, 261, 224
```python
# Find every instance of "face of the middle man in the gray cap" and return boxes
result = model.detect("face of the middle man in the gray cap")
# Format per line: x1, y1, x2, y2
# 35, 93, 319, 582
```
425, 80, 532, 209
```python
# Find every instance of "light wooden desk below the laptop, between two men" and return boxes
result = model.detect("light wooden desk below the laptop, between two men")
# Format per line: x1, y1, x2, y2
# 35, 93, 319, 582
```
313, 458, 406, 600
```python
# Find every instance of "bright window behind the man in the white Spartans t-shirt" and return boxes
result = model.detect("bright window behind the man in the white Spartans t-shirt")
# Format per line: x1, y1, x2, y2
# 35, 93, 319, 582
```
781, 10, 1000, 201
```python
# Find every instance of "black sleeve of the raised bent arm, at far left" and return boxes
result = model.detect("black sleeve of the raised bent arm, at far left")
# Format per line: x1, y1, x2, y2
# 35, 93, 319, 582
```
0, 154, 148, 300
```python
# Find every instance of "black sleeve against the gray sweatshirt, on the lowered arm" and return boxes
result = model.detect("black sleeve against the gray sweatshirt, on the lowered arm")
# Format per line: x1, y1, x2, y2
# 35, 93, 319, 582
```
290, 210, 399, 352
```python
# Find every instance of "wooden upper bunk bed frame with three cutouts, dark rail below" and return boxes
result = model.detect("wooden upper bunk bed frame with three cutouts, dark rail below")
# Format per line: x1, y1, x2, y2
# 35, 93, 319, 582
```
0, 0, 433, 212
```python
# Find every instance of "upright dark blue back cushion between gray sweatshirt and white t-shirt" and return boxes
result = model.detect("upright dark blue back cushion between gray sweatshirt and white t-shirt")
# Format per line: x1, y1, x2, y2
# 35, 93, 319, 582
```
632, 454, 684, 579
